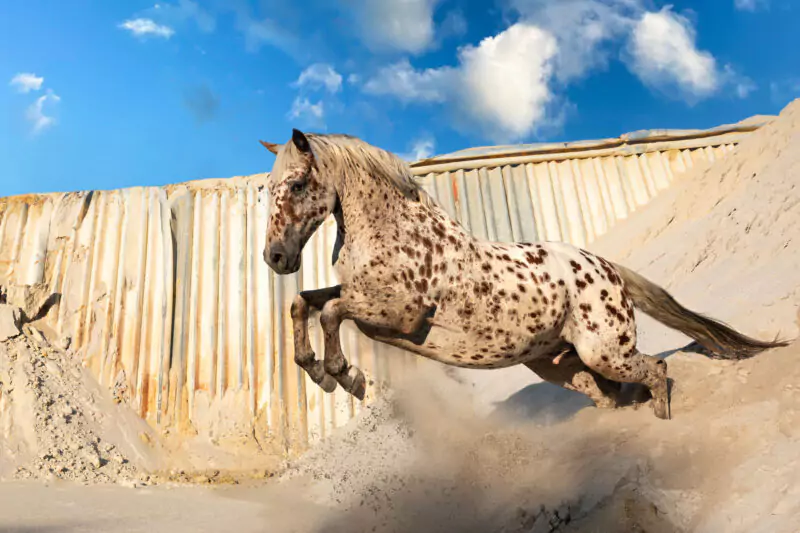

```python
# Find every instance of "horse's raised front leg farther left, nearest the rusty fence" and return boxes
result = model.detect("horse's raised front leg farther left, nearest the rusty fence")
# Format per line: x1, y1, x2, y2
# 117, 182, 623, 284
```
292, 285, 342, 392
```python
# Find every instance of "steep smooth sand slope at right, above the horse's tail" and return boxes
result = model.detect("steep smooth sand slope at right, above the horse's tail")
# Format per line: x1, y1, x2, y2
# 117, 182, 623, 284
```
591, 100, 800, 350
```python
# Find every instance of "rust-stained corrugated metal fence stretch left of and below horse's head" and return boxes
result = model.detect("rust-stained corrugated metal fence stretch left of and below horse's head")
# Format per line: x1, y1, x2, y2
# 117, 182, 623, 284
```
0, 180, 413, 454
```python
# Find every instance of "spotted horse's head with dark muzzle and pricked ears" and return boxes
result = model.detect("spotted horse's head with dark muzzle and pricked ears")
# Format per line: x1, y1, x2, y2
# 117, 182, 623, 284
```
261, 130, 336, 274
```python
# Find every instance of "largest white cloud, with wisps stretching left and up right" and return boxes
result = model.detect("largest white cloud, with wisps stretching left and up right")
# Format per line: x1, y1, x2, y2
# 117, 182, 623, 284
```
363, 0, 643, 142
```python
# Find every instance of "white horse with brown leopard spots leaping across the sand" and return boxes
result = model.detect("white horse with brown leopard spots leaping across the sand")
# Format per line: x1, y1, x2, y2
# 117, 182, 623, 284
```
260, 129, 788, 419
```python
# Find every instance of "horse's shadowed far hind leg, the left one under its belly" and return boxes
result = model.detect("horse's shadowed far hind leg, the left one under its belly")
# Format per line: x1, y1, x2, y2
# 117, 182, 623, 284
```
525, 349, 620, 409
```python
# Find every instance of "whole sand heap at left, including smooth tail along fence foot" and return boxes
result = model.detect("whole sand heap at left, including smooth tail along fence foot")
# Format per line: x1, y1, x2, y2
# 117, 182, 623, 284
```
0, 303, 296, 487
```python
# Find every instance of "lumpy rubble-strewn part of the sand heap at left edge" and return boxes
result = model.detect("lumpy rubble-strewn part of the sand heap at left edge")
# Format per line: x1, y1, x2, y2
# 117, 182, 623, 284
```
0, 305, 147, 484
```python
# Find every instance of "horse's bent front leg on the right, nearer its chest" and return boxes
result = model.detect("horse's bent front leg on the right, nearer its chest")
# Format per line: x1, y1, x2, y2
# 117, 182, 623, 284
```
319, 298, 367, 400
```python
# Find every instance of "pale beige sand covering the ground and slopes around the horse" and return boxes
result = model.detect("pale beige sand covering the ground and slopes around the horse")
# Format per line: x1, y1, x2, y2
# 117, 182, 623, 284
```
0, 97, 800, 533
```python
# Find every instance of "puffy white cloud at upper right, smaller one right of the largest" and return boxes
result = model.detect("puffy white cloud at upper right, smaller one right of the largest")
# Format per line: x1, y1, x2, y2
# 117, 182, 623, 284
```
628, 6, 723, 100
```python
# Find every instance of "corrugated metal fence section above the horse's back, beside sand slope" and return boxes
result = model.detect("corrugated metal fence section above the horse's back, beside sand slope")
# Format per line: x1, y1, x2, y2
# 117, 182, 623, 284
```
412, 120, 764, 246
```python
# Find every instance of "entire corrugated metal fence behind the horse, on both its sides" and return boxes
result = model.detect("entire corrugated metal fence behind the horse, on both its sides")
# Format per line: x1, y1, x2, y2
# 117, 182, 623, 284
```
0, 118, 776, 456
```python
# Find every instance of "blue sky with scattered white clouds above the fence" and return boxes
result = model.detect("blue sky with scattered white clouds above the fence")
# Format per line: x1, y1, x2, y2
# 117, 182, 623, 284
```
0, 0, 800, 196
